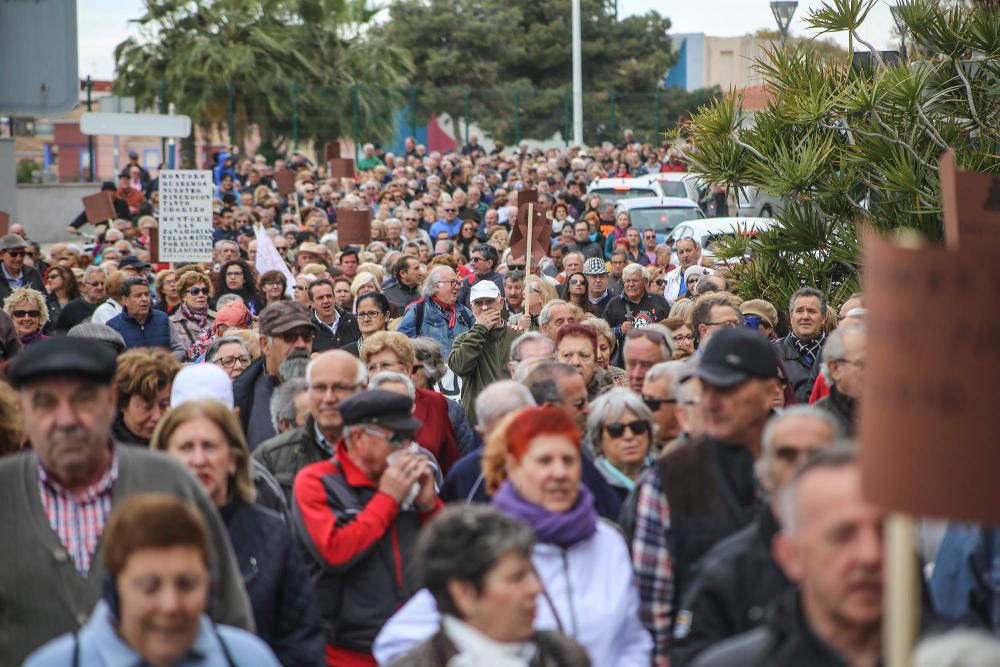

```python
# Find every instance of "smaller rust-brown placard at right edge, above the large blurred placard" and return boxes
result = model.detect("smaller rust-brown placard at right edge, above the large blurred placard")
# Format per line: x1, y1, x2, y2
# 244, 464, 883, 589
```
940, 149, 1000, 249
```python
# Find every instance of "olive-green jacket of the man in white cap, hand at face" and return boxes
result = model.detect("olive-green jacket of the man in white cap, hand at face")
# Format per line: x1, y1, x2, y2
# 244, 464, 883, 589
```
448, 324, 521, 424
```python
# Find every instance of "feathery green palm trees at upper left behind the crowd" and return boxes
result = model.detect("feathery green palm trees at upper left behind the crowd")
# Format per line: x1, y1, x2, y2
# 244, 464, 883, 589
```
115, 0, 411, 159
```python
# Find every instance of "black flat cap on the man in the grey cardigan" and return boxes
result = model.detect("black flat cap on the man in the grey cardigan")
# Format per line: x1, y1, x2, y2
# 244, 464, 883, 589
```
7, 336, 118, 389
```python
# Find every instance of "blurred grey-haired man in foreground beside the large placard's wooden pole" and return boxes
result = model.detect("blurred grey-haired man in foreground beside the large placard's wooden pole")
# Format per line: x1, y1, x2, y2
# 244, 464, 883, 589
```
694, 445, 886, 667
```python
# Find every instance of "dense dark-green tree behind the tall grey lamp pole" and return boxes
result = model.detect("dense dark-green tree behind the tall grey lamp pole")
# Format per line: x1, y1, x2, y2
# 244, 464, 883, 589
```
377, 0, 684, 143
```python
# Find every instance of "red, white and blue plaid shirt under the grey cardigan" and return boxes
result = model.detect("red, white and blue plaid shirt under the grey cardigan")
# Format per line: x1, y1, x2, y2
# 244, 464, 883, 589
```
38, 449, 118, 576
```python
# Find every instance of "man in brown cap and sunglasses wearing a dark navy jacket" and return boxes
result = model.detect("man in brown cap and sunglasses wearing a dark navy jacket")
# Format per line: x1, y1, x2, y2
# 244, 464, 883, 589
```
233, 301, 316, 450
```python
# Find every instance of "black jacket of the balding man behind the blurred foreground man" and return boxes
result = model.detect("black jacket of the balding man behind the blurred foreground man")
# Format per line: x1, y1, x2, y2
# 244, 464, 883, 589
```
670, 504, 792, 667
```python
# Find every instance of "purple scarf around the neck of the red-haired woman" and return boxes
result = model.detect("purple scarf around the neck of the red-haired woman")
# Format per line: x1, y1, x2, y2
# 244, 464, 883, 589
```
493, 480, 597, 549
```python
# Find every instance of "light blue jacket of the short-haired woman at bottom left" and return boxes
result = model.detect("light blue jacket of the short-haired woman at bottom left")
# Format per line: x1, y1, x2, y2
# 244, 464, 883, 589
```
24, 600, 281, 667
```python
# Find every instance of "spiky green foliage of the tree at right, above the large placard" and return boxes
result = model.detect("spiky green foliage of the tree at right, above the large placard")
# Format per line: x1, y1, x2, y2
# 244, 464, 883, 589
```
687, 0, 1000, 303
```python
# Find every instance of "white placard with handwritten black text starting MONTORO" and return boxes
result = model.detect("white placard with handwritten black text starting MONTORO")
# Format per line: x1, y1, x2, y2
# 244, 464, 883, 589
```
159, 169, 215, 262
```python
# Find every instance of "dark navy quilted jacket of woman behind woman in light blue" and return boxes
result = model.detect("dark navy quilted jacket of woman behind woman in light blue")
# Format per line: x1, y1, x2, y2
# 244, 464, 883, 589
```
219, 499, 325, 667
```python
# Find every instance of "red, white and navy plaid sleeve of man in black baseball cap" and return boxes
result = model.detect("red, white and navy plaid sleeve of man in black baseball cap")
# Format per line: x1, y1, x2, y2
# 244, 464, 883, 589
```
632, 465, 674, 667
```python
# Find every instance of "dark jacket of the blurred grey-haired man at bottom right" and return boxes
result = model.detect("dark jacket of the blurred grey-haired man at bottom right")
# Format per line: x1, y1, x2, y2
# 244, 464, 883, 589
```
692, 591, 848, 667
